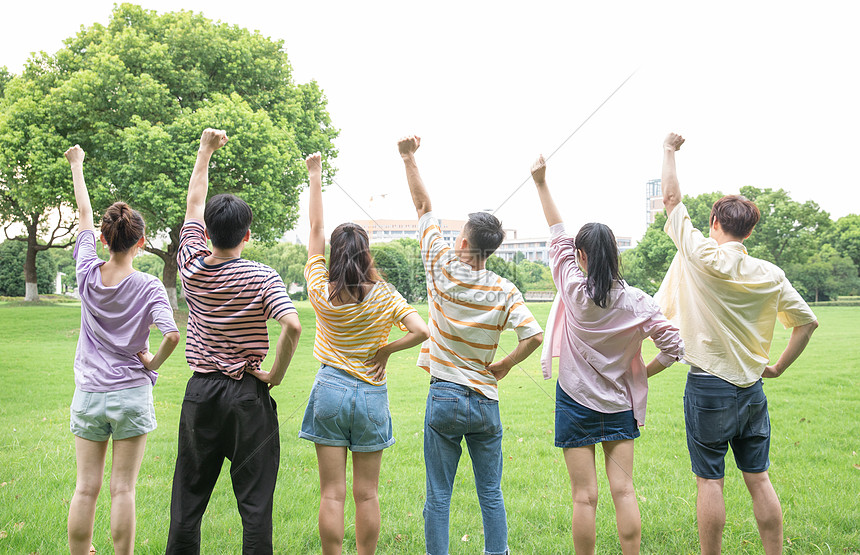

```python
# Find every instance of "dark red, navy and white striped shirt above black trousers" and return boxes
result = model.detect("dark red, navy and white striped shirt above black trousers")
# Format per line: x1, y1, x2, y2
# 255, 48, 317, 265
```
176, 220, 296, 380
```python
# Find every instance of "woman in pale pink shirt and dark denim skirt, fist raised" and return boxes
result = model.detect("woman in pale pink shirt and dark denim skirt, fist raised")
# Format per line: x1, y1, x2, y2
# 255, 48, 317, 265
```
532, 156, 684, 555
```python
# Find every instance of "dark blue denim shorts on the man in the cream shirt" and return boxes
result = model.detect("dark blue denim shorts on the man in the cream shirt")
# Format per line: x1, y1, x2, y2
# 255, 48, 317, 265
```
684, 374, 770, 480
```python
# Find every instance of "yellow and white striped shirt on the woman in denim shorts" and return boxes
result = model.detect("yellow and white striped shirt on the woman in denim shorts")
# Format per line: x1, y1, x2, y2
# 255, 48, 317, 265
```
305, 254, 416, 385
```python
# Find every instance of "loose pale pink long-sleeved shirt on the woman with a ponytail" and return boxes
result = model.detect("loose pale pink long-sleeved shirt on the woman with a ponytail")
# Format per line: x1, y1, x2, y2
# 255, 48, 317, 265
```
541, 224, 684, 425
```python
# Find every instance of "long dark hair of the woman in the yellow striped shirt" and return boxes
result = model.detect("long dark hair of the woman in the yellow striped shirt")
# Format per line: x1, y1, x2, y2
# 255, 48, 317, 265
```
328, 223, 381, 303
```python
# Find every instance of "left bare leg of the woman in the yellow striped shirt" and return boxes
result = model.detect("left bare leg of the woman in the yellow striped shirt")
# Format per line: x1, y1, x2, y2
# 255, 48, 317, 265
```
314, 443, 346, 555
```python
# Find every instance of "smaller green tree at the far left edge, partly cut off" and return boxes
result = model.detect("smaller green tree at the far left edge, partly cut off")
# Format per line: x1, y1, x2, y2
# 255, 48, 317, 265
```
0, 70, 74, 301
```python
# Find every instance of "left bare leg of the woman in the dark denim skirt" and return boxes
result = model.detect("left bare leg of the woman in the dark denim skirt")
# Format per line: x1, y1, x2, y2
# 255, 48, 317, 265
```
564, 445, 597, 555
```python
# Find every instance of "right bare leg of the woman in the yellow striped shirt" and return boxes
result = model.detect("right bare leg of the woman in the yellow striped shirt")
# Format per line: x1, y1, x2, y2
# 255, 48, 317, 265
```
352, 451, 382, 555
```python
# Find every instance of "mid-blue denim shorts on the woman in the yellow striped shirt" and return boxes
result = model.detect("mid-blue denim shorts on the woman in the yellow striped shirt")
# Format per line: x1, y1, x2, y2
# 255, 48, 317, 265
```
299, 364, 394, 452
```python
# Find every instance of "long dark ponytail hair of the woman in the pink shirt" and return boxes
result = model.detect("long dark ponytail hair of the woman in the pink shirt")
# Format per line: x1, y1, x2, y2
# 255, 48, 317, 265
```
574, 223, 623, 308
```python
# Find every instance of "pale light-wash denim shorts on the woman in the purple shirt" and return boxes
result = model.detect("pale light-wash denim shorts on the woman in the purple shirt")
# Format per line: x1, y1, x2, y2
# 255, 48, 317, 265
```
69, 384, 158, 441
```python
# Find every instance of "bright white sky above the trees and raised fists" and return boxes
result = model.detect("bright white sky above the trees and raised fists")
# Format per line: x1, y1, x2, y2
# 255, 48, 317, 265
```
0, 0, 860, 243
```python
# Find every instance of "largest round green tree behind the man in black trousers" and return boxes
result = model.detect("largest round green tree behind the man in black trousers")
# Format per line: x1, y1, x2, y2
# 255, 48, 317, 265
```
45, 4, 337, 306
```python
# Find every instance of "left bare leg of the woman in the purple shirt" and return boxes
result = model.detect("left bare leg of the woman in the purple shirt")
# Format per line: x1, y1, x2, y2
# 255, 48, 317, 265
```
68, 436, 107, 555
